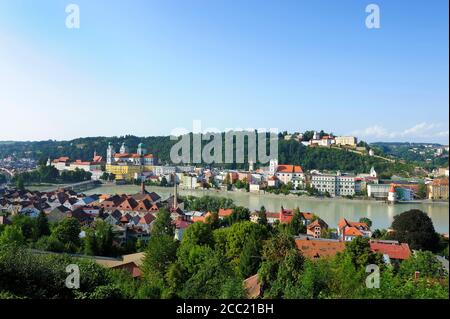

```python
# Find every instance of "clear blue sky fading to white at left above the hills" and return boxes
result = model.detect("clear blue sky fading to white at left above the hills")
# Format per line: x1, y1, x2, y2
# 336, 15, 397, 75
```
0, 0, 449, 144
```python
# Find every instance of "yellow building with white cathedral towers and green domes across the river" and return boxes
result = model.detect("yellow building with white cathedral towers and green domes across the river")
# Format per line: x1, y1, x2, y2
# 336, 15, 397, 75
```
105, 143, 154, 180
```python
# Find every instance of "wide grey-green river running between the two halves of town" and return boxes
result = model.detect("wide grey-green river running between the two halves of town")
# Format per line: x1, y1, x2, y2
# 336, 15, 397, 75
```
85, 185, 449, 233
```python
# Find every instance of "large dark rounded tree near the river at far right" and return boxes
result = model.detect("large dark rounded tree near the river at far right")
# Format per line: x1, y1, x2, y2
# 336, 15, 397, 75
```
391, 209, 439, 252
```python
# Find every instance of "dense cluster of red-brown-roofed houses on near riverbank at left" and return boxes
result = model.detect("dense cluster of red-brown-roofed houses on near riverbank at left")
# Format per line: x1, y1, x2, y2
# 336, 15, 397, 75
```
0, 184, 192, 245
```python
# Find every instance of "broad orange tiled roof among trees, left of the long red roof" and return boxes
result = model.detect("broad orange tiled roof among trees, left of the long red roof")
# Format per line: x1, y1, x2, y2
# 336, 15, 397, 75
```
295, 239, 345, 259
